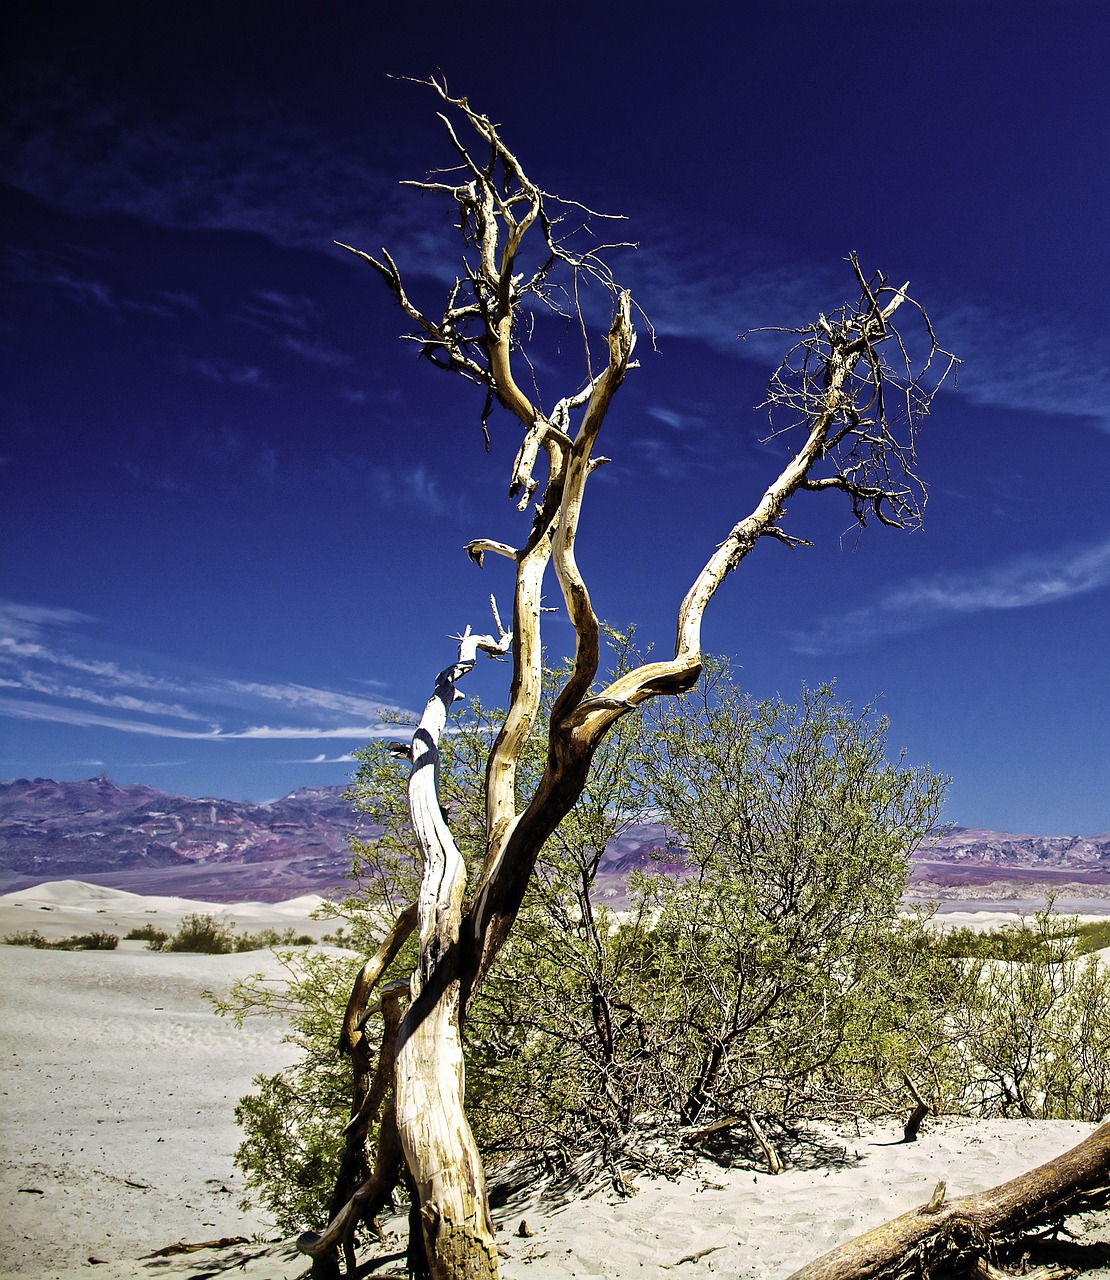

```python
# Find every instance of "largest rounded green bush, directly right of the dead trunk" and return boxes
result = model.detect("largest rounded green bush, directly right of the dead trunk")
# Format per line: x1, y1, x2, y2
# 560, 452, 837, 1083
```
467, 662, 944, 1167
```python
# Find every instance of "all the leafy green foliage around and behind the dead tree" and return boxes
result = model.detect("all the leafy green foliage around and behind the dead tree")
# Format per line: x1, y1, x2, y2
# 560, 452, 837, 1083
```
224, 655, 1110, 1230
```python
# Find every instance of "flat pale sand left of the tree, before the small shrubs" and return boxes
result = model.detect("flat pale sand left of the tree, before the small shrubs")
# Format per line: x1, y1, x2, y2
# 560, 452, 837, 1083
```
0, 947, 299, 1277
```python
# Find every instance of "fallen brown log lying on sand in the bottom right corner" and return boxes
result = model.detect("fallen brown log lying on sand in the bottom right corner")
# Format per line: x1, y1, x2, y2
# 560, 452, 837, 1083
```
789, 1124, 1110, 1280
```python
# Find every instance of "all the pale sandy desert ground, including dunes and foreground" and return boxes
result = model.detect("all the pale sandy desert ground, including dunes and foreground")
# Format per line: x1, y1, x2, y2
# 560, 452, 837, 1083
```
0, 882, 1110, 1280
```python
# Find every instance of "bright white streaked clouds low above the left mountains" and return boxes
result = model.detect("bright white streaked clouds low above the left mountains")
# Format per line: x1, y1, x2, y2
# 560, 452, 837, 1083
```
0, 602, 414, 741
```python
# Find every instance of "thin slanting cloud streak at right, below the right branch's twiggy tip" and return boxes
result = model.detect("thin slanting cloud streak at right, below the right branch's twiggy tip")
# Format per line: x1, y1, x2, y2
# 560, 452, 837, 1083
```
791, 539, 1110, 654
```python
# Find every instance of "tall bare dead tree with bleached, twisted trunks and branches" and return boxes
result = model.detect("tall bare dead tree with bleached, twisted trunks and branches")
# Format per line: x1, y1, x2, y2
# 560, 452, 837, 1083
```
306, 81, 953, 1280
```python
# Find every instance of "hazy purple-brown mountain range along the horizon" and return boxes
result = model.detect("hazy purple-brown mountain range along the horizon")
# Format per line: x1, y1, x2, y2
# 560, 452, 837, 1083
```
0, 776, 1110, 902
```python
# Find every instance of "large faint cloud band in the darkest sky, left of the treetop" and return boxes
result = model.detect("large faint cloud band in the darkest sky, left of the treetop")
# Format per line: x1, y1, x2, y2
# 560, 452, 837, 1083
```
0, 68, 442, 270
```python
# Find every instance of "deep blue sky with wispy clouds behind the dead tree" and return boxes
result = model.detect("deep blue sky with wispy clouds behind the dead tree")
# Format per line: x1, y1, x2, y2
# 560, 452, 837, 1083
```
0, 0, 1110, 835
